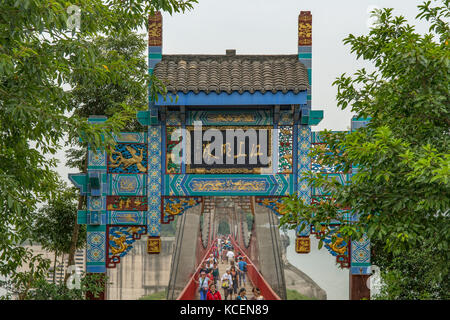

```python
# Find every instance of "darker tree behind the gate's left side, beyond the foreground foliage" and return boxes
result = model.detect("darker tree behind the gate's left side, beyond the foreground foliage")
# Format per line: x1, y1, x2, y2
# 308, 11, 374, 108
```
62, 30, 151, 278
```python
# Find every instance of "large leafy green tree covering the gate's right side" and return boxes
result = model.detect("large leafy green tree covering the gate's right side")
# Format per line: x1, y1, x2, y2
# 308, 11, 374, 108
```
282, 0, 450, 298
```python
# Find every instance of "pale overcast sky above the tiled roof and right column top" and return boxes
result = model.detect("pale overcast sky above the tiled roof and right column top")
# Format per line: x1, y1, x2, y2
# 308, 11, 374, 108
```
163, 0, 425, 130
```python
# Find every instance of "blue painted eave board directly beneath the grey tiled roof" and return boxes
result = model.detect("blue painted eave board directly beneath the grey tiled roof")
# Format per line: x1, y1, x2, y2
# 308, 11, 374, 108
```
155, 90, 307, 106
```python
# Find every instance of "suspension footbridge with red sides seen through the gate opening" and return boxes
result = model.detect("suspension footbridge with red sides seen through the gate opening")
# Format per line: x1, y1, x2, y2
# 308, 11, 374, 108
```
167, 197, 286, 300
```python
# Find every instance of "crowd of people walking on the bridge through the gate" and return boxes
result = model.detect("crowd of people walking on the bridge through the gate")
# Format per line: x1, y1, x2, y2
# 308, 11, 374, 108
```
198, 236, 264, 300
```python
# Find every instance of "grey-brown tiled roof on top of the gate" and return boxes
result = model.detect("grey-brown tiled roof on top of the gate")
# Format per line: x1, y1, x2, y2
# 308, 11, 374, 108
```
154, 55, 309, 93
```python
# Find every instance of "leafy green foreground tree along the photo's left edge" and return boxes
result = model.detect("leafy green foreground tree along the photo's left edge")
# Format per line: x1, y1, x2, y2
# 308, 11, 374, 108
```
0, 0, 196, 296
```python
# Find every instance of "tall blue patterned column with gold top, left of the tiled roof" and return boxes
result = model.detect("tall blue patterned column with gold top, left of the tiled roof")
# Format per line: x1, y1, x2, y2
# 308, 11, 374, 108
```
147, 11, 163, 253
